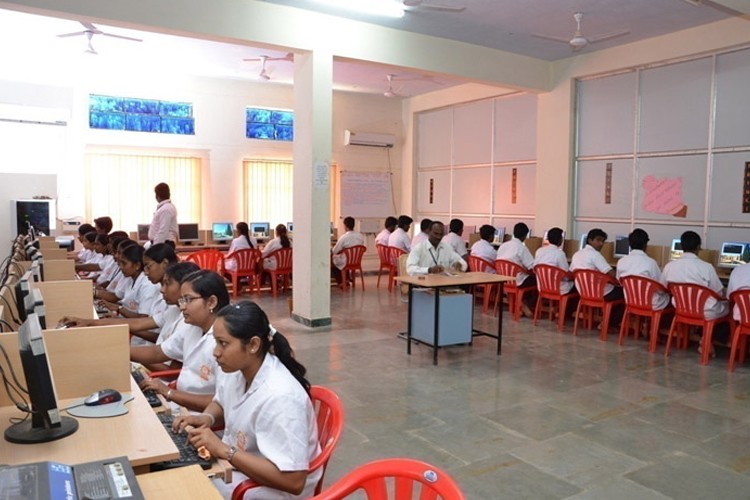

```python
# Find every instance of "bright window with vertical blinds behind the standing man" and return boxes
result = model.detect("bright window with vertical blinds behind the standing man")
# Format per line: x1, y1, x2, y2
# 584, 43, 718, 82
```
85, 153, 201, 231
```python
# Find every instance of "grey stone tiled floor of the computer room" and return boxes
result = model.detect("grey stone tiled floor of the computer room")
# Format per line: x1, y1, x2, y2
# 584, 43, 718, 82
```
245, 276, 750, 500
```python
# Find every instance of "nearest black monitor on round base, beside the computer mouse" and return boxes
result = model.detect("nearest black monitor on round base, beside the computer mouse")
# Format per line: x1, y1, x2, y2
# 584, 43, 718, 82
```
5, 313, 78, 444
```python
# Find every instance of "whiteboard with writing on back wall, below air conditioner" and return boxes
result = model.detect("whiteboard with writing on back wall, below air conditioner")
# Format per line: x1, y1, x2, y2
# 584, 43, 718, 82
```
339, 171, 395, 218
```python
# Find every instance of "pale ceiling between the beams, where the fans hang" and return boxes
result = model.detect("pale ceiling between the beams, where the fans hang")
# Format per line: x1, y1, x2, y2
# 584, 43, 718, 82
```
0, 0, 744, 97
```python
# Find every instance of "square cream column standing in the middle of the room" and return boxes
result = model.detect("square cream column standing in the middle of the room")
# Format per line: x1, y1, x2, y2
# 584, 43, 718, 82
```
292, 51, 333, 327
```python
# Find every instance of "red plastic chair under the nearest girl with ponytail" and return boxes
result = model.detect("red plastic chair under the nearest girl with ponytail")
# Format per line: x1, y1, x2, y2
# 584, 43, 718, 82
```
232, 385, 344, 500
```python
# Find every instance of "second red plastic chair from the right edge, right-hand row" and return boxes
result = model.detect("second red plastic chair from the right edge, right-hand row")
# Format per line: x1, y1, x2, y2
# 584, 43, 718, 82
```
664, 283, 731, 365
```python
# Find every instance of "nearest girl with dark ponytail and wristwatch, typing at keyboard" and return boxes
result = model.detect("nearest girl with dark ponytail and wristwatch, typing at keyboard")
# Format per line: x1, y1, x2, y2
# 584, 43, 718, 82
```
173, 301, 323, 499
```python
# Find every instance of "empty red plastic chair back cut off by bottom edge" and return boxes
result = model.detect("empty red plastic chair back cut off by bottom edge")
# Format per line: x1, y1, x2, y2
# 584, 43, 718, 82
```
313, 458, 466, 500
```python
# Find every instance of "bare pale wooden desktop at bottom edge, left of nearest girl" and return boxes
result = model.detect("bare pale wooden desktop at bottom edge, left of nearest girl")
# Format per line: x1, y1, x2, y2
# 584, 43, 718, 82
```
136, 465, 222, 500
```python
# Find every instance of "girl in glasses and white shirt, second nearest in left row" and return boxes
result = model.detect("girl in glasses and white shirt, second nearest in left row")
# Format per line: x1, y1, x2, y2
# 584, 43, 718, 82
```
135, 269, 229, 411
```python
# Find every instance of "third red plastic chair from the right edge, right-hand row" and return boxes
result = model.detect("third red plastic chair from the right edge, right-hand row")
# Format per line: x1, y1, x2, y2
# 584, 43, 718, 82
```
618, 275, 674, 352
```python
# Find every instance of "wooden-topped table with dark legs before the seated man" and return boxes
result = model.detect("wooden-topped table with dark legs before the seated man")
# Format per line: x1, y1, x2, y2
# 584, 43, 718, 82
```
396, 272, 516, 365
